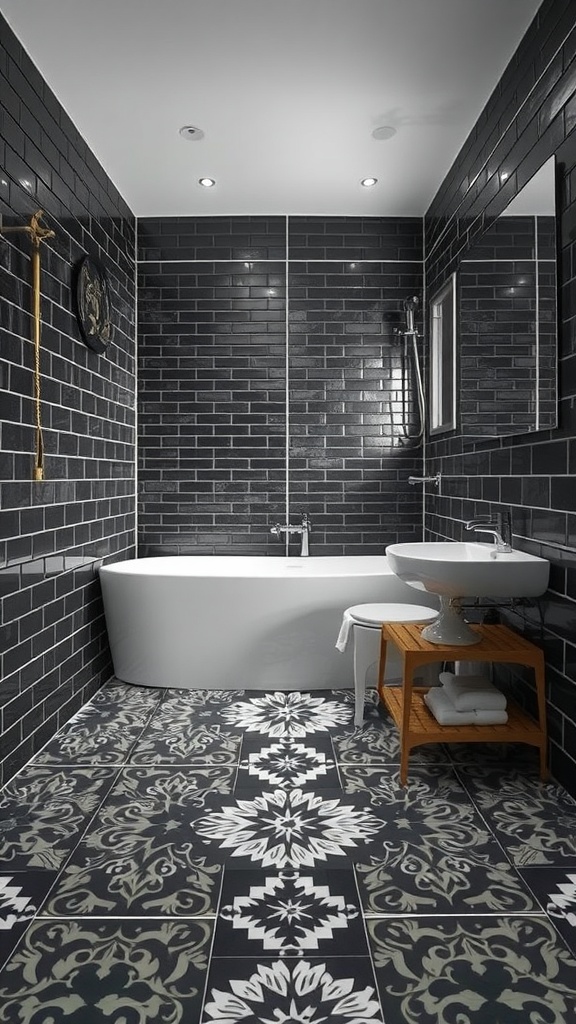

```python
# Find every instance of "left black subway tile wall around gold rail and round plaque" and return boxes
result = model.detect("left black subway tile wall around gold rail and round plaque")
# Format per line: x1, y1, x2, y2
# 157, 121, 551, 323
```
0, 17, 135, 780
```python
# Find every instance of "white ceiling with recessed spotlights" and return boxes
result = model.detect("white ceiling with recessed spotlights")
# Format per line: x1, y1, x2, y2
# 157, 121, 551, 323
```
0, 0, 540, 216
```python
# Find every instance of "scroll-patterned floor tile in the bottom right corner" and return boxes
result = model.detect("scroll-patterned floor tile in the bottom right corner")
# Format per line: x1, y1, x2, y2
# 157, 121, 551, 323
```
368, 916, 576, 1024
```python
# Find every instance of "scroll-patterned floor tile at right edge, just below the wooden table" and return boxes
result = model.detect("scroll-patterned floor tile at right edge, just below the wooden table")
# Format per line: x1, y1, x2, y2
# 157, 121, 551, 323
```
458, 765, 576, 867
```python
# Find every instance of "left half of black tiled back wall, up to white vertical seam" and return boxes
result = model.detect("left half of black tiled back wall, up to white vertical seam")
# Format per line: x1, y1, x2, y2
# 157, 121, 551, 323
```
138, 217, 286, 556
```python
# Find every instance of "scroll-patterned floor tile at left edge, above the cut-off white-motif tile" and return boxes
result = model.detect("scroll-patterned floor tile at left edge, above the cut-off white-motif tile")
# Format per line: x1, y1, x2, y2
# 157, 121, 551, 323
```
0, 764, 117, 870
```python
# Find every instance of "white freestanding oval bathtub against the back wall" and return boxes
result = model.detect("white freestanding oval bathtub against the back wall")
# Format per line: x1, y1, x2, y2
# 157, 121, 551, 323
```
99, 555, 436, 690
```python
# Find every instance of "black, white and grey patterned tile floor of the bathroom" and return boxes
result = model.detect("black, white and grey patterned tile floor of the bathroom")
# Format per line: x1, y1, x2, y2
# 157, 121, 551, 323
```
0, 683, 576, 1024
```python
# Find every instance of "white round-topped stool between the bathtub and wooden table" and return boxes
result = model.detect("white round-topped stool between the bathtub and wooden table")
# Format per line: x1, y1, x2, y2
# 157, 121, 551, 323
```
344, 602, 438, 725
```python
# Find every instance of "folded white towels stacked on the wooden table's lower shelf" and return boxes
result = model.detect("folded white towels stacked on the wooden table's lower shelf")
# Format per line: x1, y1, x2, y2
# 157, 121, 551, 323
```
424, 662, 508, 725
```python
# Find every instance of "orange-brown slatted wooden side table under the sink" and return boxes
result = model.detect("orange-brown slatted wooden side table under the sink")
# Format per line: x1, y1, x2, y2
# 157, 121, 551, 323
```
378, 623, 548, 785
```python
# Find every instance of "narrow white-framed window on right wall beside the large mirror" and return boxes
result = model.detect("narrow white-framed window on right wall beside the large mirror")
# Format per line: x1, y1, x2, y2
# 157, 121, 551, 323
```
429, 273, 456, 434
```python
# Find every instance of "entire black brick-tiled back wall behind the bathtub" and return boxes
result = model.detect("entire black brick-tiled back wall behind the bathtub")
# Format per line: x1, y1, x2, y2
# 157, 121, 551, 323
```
138, 217, 422, 555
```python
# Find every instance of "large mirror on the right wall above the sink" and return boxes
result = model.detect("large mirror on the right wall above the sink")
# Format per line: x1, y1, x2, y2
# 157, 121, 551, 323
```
458, 157, 558, 437
